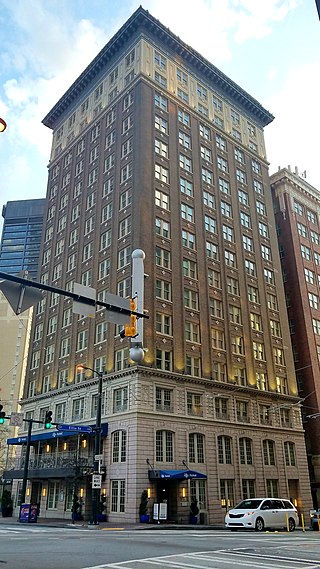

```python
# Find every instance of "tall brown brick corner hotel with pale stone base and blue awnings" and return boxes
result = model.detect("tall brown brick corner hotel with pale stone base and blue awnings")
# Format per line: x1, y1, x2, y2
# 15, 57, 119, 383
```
3, 8, 311, 523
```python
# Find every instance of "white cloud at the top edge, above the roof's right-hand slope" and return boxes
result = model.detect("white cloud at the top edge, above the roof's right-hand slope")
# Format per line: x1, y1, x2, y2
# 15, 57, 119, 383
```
144, 0, 302, 65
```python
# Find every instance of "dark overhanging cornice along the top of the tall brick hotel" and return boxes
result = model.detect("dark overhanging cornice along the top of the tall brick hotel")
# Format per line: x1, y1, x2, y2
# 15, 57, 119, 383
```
42, 6, 274, 128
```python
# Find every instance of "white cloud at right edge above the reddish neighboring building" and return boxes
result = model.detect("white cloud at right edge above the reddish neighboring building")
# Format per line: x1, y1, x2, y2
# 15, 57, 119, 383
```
265, 61, 320, 191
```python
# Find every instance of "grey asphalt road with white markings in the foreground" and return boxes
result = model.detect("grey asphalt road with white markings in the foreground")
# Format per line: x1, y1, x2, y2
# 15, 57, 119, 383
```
0, 524, 320, 569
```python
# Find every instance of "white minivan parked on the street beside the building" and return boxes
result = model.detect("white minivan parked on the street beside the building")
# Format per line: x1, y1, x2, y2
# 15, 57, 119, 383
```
225, 498, 299, 531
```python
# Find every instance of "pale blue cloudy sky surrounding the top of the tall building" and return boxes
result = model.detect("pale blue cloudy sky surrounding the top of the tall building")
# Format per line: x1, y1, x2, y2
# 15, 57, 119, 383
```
0, 0, 320, 224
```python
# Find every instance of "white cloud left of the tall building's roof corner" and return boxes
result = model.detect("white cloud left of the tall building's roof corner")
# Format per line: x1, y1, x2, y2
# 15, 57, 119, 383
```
3, 0, 107, 157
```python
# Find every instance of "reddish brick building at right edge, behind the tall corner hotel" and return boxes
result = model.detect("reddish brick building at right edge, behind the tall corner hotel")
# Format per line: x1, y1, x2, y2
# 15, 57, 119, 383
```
271, 168, 320, 508
